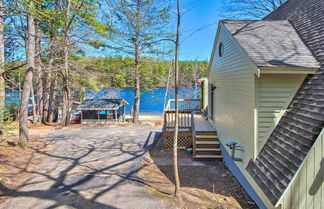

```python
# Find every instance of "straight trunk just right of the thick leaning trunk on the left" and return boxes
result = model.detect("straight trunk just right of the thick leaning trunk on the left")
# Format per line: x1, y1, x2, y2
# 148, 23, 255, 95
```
35, 20, 43, 123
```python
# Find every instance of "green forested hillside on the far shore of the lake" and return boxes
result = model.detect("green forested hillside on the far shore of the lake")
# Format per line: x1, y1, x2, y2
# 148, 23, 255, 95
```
71, 57, 208, 89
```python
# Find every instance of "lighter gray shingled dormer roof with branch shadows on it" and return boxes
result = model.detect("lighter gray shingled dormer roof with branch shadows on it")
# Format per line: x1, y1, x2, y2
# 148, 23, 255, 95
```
222, 20, 319, 69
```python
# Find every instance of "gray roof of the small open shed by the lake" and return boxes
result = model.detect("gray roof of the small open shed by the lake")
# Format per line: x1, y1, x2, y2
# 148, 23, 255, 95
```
77, 99, 128, 110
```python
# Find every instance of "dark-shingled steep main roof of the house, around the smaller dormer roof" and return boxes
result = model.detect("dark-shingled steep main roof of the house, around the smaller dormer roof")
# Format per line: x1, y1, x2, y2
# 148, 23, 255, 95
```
247, 0, 324, 206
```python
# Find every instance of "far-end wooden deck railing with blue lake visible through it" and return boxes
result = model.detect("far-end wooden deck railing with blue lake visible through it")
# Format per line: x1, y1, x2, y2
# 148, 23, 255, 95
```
165, 99, 202, 111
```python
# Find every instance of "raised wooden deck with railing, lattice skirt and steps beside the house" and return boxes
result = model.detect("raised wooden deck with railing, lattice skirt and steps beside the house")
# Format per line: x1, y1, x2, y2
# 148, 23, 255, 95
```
162, 100, 223, 160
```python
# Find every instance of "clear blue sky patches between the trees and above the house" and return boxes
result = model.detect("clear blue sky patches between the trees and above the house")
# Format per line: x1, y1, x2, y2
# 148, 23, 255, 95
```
8, 0, 262, 61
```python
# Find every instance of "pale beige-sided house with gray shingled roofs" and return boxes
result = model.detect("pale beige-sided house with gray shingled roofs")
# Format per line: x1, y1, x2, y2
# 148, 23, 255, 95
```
208, 0, 324, 209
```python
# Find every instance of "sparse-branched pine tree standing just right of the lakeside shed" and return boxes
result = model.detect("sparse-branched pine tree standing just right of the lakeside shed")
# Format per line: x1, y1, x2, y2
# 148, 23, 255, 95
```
106, 0, 169, 123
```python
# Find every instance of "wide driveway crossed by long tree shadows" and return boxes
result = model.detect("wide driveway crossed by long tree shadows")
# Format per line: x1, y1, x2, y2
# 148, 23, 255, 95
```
3, 125, 175, 209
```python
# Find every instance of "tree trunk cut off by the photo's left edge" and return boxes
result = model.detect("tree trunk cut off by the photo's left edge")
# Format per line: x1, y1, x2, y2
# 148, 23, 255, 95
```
0, 0, 6, 141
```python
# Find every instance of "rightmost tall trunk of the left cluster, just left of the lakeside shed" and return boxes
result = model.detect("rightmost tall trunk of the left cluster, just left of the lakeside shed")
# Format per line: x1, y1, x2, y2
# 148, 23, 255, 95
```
61, 0, 71, 125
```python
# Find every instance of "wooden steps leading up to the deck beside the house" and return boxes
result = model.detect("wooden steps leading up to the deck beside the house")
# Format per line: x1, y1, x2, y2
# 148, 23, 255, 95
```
193, 131, 223, 160
